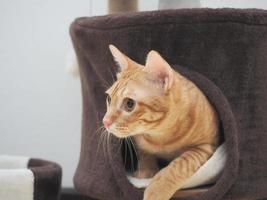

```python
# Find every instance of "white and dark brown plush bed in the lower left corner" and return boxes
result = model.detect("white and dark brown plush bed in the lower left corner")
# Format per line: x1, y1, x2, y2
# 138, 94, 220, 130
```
0, 155, 61, 200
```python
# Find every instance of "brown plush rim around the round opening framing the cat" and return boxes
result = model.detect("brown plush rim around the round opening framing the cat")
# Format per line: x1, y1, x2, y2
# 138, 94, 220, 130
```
105, 65, 239, 200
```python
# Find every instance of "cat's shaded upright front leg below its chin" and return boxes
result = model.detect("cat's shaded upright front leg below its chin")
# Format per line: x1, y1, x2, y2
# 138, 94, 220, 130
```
133, 149, 159, 178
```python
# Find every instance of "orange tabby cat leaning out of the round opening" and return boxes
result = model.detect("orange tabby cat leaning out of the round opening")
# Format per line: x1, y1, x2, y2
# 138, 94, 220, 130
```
103, 45, 219, 200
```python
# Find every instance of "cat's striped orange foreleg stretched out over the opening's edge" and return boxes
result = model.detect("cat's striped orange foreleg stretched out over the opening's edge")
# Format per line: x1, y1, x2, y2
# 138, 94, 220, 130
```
144, 144, 215, 200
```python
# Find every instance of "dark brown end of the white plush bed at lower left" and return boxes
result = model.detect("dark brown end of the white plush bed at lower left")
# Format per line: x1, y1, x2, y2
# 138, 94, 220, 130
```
28, 159, 62, 200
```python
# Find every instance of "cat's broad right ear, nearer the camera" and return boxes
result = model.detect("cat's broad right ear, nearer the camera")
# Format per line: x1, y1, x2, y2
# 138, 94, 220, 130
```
145, 50, 174, 91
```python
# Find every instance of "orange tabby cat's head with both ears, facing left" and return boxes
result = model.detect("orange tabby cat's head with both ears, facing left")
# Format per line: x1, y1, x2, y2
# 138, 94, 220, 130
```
103, 45, 173, 138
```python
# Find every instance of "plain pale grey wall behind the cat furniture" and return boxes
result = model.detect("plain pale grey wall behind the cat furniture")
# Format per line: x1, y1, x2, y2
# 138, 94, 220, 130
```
0, 0, 267, 187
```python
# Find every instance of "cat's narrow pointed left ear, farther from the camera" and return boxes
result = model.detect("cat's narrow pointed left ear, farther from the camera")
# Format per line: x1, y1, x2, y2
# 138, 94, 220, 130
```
109, 44, 129, 71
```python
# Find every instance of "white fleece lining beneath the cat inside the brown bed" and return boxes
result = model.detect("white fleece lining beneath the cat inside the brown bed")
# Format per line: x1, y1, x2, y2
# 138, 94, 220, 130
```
127, 144, 226, 189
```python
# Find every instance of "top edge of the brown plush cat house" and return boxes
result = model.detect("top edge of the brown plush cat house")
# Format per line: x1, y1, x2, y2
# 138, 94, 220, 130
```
73, 8, 267, 31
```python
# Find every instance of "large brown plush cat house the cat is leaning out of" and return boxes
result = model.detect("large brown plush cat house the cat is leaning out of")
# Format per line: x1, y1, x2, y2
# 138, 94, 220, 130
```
71, 9, 267, 200
